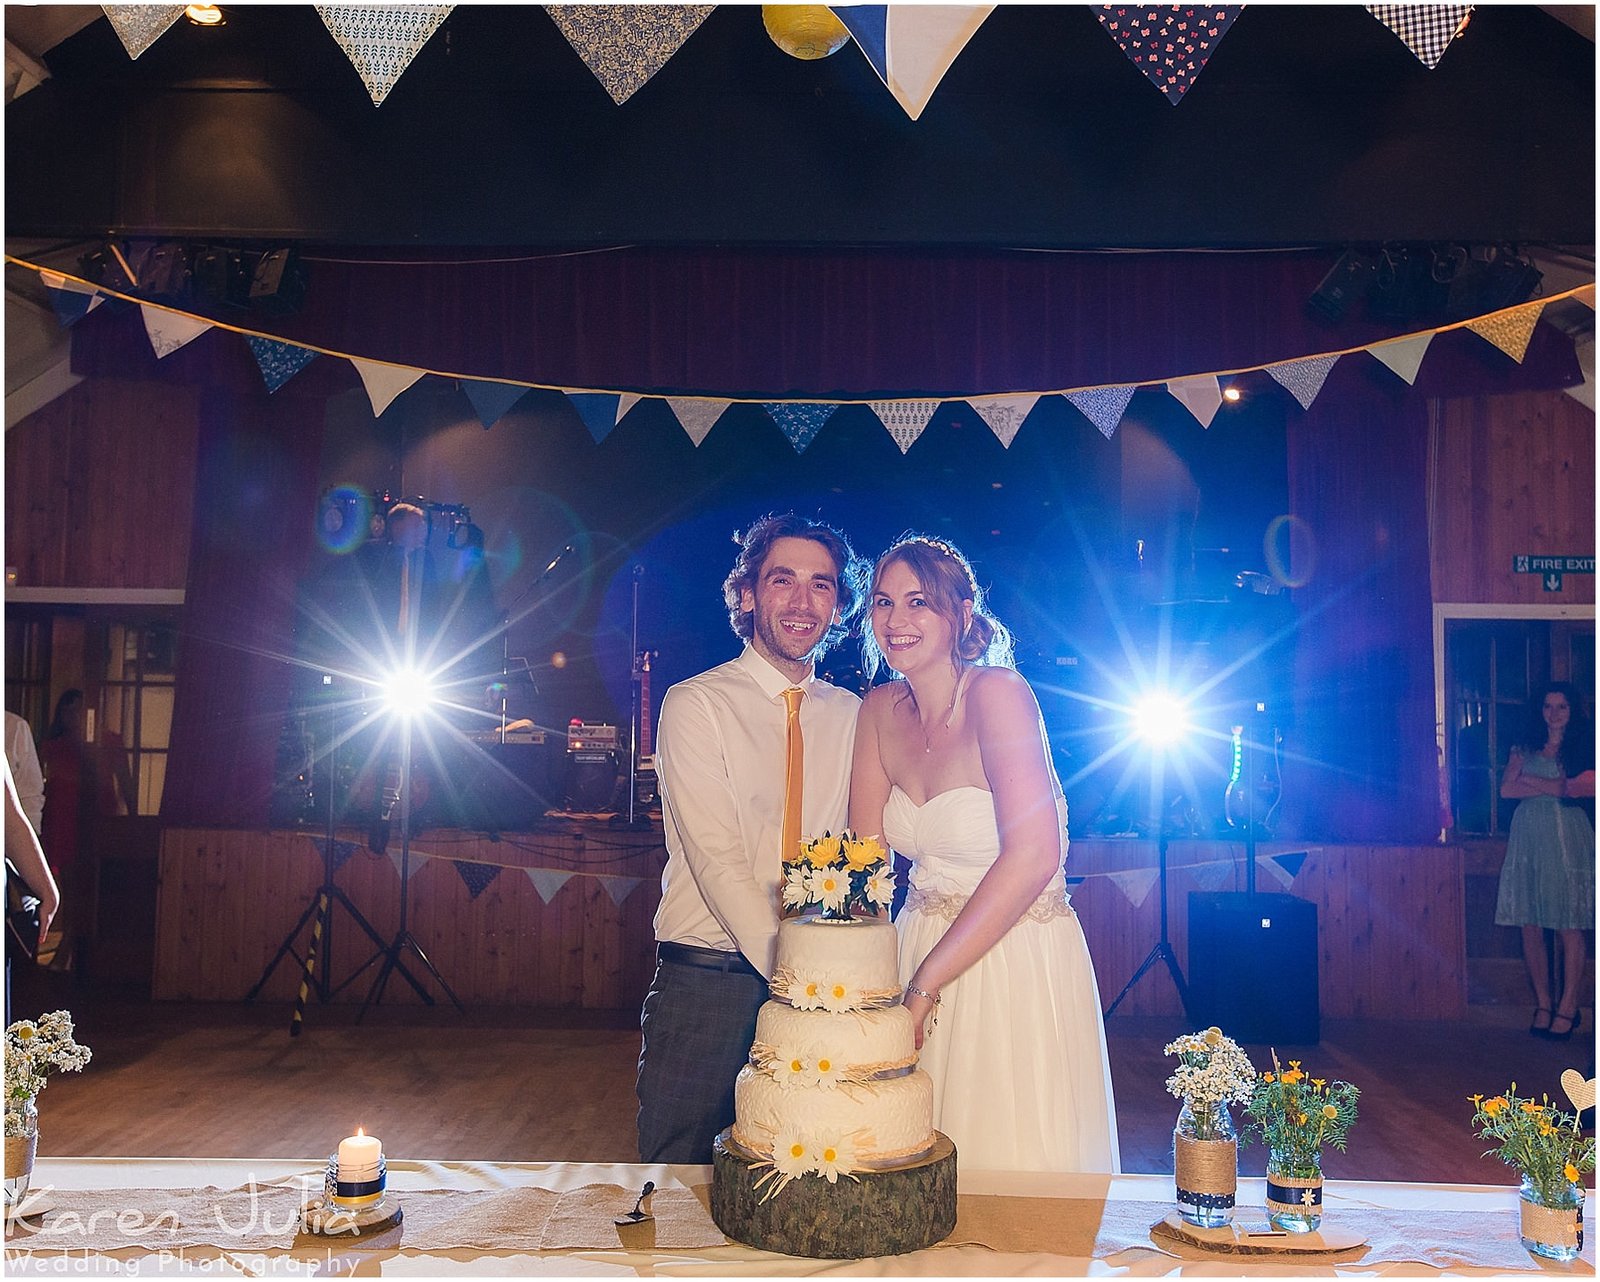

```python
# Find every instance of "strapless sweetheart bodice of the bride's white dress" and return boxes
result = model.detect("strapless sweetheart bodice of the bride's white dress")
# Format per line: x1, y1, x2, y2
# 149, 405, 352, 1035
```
883, 784, 1067, 895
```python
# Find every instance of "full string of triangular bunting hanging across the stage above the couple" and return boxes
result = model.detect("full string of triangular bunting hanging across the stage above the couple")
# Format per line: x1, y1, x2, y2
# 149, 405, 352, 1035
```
5, 254, 1595, 455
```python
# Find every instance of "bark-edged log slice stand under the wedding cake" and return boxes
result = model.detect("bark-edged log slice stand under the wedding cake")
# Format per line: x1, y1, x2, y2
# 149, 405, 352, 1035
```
710, 1132, 955, 1260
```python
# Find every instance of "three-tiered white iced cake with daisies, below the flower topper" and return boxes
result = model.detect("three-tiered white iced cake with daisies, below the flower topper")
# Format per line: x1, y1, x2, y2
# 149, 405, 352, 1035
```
733, 917, 934, 1178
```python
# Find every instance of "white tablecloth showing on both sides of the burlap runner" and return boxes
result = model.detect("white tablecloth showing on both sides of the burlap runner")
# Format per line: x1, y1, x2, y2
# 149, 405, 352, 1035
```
6, 1157, 1594, 1277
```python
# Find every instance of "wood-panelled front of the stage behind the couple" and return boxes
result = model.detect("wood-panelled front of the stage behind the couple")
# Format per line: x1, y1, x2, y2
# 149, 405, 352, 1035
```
154, 819, 1467, 1020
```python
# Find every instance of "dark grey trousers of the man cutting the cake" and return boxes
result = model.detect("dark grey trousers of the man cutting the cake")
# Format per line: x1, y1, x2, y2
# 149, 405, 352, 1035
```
637, 960, 766, 1164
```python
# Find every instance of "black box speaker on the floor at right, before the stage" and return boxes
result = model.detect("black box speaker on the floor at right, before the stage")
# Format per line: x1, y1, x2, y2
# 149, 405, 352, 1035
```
1189, 890, 1322, 1047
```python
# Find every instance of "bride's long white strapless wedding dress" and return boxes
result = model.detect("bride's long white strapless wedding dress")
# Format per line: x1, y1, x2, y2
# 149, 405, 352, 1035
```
883, 784, 1122, 1172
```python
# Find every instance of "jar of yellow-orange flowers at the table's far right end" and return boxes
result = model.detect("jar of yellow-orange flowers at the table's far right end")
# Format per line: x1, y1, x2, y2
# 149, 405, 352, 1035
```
1470, 1082, 1595, 1260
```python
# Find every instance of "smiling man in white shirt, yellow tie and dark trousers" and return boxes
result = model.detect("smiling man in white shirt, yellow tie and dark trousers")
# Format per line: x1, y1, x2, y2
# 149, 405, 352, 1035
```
638, 514, 867, 1164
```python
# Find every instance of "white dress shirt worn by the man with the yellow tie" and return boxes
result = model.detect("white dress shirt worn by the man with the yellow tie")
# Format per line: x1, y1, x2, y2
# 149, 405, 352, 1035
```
656, 645, 861, 976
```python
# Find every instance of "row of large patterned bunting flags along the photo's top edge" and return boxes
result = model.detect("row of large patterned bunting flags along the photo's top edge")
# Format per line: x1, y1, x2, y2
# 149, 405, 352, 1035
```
101, 3, 1472, 120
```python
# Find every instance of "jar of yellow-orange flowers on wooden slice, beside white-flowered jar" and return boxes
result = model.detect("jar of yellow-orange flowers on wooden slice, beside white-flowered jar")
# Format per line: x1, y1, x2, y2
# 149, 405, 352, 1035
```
1245, 1050, 1362, 1232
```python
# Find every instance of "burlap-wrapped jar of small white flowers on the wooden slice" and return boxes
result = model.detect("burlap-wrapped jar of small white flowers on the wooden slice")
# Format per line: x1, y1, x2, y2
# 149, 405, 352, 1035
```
1163, 1028, 1256, 1229
